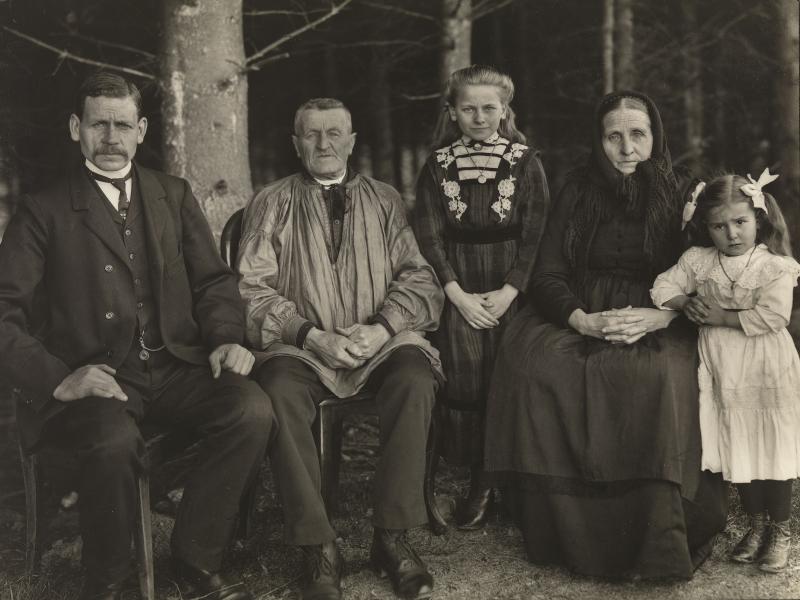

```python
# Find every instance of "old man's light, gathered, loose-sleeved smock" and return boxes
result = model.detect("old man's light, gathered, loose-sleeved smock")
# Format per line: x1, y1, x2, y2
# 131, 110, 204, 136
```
238, 174, 444, 398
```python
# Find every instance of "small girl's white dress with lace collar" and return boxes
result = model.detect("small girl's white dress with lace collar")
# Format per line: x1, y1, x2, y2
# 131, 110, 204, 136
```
650, 244, 800, 483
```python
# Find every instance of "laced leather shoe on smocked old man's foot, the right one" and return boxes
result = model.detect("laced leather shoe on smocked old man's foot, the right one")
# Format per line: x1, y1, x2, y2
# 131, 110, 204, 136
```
369, 527, 433, 598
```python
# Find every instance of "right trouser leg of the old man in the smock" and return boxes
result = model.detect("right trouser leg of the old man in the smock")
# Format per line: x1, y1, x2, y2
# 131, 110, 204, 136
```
367, 346, 438, 529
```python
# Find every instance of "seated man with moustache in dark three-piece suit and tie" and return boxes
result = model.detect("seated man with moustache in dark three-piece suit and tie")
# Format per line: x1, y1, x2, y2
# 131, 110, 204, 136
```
0, 73, 275, 600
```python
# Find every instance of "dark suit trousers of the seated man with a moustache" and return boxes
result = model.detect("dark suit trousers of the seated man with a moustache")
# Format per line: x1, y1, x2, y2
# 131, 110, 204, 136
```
46, 358, 275, 583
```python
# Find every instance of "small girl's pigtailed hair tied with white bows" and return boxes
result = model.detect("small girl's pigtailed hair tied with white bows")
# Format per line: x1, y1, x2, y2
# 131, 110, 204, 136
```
690, 174, 792, 256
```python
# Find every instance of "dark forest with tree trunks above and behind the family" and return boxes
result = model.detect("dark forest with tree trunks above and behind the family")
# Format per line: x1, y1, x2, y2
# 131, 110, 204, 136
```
0, 0, 800, 239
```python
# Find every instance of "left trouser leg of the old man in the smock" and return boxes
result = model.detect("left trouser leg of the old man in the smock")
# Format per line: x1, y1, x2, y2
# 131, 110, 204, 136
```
256, 357, 336, 546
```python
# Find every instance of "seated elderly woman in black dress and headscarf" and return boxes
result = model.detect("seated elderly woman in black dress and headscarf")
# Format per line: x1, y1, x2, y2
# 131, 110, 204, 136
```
485, 92, 727, 578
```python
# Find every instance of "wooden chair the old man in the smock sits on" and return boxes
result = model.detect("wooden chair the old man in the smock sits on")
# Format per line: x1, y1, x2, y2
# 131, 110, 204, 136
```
225, 209, 447, 535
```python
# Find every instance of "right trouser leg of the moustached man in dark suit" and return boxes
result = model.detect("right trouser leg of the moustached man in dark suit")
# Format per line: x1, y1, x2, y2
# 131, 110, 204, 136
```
147, 365, 277, 571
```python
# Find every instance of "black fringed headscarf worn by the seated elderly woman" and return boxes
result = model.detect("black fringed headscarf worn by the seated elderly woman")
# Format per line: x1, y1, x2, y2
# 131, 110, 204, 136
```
564, 91, 682, 272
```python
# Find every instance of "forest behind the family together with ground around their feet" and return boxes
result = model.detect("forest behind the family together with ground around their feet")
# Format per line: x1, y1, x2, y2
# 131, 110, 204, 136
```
0, 0, 800, 600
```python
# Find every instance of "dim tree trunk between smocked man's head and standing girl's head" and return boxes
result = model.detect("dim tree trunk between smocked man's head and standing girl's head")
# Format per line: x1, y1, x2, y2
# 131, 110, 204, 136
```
369, 49, 396, 185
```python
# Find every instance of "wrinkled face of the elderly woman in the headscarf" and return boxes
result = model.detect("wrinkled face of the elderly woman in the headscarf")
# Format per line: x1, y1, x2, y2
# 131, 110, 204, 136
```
603, 107, 653, 175
